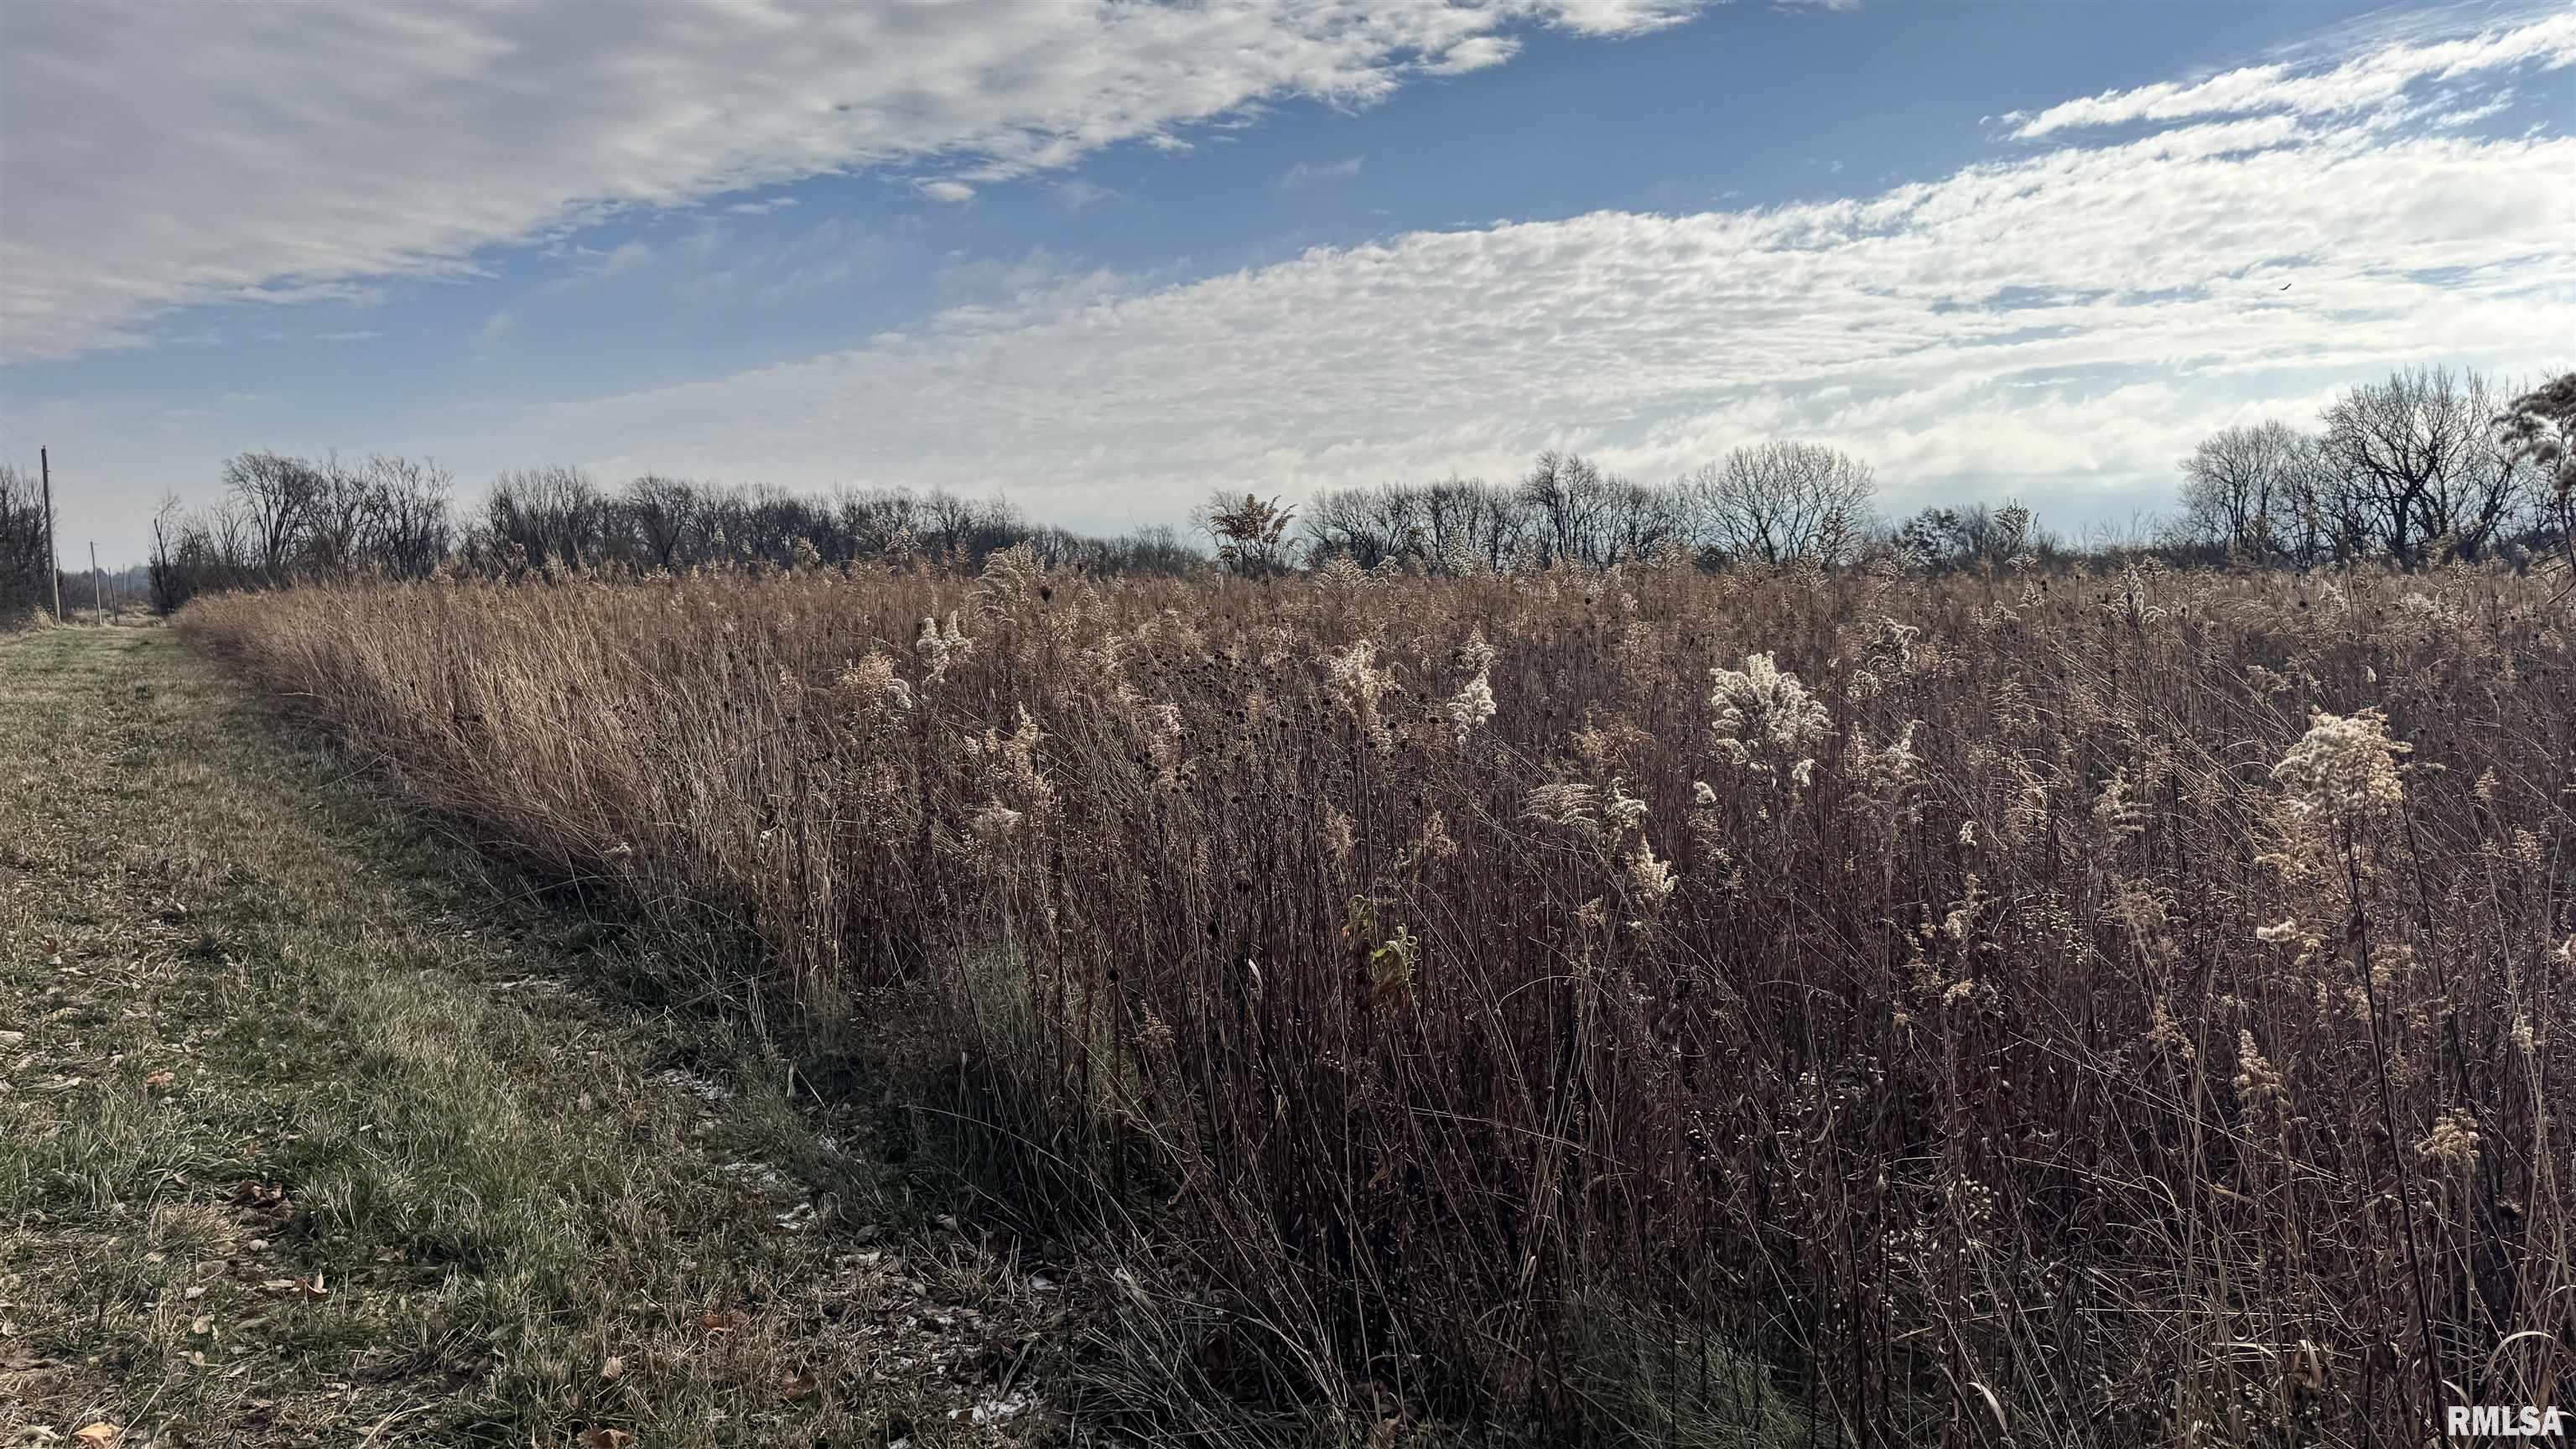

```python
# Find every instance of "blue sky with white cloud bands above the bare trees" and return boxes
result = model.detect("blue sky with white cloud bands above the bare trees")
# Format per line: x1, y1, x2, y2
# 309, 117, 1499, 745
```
0, 0, 2576, 562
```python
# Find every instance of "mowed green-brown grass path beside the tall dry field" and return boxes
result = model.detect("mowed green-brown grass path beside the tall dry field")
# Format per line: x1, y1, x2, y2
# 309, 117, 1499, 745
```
0, 629, 1062, 1449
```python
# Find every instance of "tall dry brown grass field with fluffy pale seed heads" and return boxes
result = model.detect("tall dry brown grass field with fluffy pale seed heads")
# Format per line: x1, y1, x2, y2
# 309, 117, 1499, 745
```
183, 552, 2576, 1444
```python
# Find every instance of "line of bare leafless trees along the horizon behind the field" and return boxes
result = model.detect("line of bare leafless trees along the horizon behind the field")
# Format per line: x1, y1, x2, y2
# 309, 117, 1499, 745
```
60, 369, 2576, 614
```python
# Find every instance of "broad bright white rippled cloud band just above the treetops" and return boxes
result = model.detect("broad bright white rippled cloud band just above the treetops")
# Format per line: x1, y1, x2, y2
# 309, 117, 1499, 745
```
497, 96, 2576, 526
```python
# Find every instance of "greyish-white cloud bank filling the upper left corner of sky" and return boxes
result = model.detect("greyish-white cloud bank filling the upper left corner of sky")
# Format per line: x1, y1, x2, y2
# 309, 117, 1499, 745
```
0, 0, 1701, 358
